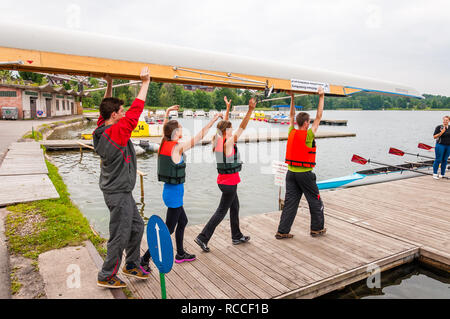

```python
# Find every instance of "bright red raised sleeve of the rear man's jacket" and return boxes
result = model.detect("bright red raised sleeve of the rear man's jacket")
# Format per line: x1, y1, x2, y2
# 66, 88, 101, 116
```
105, 99, 145, 146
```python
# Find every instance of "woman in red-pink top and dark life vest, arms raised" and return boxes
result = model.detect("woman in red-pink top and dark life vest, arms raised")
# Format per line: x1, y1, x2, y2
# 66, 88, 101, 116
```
194, 97, 256, 252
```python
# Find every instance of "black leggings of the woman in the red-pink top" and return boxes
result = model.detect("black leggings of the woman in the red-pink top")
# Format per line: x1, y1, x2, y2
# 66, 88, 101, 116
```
198, 184, 243, 243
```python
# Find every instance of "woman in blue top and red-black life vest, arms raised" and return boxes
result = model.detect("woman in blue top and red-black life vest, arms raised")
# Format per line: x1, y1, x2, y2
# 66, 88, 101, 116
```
141, 105, 222, 271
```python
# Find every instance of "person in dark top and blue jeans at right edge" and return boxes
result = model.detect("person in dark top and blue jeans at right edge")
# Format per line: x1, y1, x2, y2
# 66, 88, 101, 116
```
433, 115, 450, 179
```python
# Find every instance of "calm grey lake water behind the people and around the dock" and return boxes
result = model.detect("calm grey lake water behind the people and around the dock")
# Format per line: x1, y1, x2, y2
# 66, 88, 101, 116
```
46, 111, 450, 298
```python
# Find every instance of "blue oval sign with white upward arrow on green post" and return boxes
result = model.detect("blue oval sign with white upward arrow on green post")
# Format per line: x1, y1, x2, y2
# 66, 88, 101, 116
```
147, 215, 173, 299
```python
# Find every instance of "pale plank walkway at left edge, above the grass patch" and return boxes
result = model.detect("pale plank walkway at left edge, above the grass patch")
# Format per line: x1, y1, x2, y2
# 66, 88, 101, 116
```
0, 142, 59, 207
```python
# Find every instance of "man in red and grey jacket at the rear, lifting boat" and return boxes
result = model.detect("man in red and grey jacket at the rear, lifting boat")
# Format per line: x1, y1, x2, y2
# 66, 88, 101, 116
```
93, 67, 150, 288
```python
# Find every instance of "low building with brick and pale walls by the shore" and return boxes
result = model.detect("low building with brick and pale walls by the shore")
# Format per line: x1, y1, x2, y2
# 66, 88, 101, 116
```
0, 84, 87, 119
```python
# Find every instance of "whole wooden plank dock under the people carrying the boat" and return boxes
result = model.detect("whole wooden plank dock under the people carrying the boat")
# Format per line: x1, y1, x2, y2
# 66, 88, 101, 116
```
118, 176, 450, 299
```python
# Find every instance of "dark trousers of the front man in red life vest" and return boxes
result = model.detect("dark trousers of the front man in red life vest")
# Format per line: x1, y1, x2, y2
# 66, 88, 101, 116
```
278, 171, 325, 234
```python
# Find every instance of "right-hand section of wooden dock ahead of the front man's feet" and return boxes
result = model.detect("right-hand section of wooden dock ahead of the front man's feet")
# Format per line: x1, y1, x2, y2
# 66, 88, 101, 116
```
322, 176, 450, 271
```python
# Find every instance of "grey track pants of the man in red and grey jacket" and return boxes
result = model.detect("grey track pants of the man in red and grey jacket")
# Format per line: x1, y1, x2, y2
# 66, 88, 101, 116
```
98, 192, 144, 281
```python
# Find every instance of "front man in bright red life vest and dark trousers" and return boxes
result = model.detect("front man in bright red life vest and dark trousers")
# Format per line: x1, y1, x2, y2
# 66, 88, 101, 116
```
275, 87, 326, 239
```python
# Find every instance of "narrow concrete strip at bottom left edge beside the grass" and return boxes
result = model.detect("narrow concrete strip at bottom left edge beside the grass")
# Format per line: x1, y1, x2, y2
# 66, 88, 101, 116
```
0, 208, 11, 299
